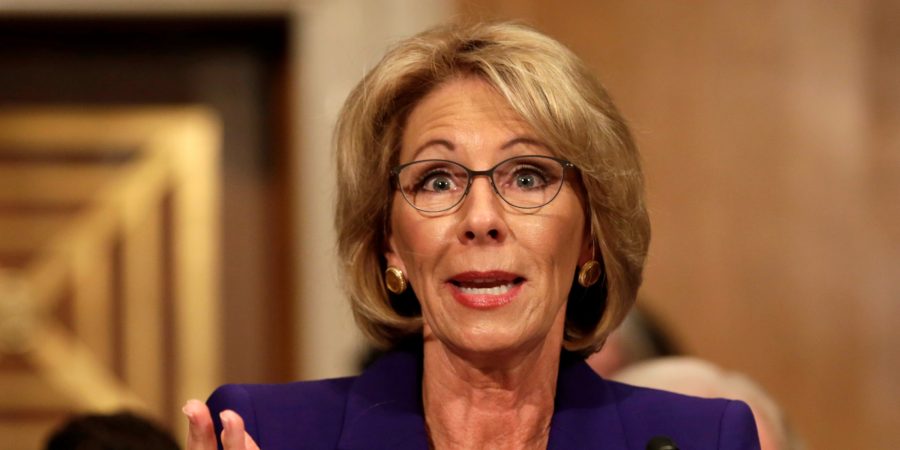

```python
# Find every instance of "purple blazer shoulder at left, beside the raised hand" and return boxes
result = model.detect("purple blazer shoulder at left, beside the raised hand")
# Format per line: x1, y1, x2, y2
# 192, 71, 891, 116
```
206, 377, 354, 450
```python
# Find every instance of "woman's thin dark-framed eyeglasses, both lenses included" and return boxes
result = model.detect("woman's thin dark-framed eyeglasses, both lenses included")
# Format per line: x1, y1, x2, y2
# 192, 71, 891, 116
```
391, 155, 575, 213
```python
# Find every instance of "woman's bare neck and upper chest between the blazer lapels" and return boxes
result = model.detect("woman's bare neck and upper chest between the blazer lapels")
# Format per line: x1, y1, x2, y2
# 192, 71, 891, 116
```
422, 333, 562, 450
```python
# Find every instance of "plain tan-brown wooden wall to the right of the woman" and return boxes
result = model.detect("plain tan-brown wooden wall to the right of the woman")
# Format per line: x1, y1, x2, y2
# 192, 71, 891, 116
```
458, 0, 900, 449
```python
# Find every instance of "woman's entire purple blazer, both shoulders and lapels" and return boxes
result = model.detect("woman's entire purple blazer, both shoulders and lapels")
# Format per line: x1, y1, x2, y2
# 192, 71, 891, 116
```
207, 351, 759, 450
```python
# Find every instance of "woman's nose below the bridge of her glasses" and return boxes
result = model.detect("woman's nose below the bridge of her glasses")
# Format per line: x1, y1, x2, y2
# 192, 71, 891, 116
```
458, 177, 509, 244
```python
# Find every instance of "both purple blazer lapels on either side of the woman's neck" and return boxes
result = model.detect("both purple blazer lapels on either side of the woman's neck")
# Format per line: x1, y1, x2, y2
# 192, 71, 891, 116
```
338, 347, 628, 450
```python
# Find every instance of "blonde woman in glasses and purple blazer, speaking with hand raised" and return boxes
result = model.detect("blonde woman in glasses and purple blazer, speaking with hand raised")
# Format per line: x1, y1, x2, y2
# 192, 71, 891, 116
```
185, 24, 758, 450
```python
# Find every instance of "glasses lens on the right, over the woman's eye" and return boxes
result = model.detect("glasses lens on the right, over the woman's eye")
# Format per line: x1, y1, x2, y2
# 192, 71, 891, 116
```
493, 156, 565, 208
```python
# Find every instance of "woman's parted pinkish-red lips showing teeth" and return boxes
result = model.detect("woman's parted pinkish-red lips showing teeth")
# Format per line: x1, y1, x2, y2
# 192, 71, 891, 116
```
448, 271, 525, 309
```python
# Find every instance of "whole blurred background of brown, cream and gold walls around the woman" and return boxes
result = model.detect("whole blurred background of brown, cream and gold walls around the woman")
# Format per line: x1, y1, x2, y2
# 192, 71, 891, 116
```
0, 0, 900, 450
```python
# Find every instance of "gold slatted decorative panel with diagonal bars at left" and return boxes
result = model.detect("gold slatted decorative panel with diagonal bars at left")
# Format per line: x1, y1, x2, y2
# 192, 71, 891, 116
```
0, 107, 220, 450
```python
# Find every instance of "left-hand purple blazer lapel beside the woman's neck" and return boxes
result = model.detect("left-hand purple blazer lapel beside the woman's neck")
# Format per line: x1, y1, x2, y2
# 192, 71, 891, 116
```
338, 351, 428, 450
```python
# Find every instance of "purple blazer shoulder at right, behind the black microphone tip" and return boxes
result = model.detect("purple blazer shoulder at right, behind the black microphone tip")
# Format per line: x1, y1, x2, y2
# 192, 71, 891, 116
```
608, 381, 759, 450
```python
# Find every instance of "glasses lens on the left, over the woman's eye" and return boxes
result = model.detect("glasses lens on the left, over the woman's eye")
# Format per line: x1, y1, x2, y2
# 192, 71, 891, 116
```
397, 160, 468, 212
